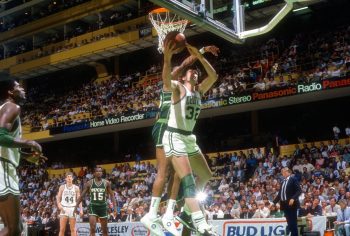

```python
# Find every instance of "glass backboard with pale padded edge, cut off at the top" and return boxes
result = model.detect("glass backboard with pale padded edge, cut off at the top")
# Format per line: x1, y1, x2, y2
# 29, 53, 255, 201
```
150, 0, 319, 44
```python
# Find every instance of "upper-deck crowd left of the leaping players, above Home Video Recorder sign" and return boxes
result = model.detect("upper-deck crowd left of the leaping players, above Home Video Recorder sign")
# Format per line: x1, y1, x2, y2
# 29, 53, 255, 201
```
23, 69, 160, 131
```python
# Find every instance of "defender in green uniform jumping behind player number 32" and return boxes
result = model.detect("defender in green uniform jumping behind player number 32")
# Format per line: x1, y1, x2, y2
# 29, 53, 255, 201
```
141, 38, 219, 236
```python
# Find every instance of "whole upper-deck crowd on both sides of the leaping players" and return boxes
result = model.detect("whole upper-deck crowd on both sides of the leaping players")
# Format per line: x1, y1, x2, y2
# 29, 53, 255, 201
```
19, 27, 350, 131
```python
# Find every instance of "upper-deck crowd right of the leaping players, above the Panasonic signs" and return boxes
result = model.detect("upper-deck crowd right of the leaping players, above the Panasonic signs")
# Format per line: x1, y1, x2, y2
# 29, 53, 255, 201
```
209, 26, 350, 98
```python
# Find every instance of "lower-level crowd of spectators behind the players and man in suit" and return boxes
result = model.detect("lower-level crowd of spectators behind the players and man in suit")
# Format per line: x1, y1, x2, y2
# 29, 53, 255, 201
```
8, 135, 350, 234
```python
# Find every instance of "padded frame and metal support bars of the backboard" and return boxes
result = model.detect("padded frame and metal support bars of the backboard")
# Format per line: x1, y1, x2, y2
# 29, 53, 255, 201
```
150, 0, 312, 44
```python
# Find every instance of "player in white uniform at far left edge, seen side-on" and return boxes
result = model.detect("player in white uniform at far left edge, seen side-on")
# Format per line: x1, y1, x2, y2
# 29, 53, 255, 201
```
0, 79, 42, 236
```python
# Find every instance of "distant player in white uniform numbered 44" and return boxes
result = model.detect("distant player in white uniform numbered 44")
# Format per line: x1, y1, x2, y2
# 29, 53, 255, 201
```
56, 172, 83, 236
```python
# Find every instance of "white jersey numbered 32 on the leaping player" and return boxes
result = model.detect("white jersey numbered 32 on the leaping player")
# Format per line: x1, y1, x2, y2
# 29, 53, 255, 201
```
168, 83, 201, 132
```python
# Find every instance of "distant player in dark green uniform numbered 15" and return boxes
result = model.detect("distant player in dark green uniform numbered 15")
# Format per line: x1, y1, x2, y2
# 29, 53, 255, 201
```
76, 167, 117, 236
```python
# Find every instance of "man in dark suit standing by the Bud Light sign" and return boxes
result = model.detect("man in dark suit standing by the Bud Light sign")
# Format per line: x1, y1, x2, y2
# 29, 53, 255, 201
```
273, 167, 301, 236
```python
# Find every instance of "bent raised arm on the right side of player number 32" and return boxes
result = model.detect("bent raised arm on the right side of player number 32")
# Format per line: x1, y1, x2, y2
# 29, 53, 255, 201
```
187, 44, 218, 94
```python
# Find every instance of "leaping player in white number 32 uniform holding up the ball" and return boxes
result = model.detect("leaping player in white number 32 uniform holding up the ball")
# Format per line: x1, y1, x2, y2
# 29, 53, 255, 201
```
163, 45, 217, 235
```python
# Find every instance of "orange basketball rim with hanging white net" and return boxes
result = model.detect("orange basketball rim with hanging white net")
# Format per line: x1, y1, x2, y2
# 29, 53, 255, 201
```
148, 8, 188, 53
